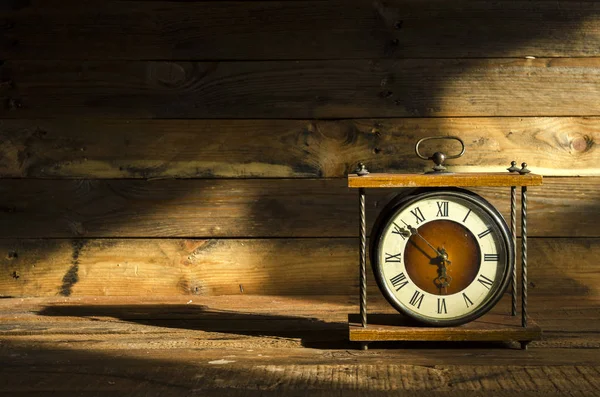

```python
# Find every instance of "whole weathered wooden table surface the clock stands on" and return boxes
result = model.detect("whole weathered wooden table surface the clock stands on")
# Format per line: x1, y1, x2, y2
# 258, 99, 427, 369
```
0, 295, 600, 397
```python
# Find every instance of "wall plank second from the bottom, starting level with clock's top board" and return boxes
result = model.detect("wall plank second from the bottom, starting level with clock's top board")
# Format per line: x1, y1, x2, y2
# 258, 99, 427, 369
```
0, 177, 600, 238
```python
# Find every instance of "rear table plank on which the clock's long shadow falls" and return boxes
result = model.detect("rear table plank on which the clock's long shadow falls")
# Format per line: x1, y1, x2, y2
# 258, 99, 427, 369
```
0, 295, 600, 348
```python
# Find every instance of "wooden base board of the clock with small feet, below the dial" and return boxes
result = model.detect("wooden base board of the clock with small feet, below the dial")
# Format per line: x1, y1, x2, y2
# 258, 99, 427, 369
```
348, 313, 542, 350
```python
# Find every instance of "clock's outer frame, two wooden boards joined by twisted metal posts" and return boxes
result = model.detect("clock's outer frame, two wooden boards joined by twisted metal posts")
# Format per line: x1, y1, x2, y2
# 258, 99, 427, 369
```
348, 162, 542, 350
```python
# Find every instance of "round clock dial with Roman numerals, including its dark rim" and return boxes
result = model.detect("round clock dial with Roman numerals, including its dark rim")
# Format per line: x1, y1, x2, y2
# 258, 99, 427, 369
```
371, 189, 514, 325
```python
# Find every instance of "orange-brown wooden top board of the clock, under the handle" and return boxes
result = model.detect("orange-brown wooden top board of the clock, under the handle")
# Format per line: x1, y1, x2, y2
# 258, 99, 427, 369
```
348, 172, 542, 188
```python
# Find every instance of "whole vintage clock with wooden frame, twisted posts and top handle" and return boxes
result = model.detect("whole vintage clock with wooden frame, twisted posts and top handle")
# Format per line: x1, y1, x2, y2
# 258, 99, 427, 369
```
349, 137, 542, 348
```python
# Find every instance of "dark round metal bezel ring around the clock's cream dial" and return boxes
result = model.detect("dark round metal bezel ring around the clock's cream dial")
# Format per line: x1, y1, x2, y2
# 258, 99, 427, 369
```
369, 187, 515, 327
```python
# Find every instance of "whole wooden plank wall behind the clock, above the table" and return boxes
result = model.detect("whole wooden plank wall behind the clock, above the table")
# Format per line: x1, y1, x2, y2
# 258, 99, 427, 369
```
0, 0, 600, 296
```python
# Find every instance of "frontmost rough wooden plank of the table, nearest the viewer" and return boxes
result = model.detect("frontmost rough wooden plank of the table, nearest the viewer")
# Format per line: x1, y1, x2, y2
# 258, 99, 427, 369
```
0, 350, 600, 397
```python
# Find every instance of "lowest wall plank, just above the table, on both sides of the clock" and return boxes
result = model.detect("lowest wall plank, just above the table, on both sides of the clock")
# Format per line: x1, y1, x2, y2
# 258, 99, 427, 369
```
0, 238, 600, 296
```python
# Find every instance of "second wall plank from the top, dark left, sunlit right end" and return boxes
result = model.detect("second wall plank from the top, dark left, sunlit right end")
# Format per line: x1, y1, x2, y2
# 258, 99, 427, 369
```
0, 58, 600, 119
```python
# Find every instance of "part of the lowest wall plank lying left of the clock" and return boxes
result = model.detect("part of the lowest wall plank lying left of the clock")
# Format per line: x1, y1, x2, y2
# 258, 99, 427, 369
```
0, 235, 356, 296
